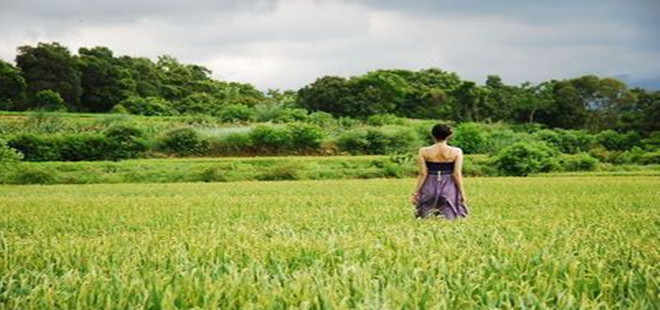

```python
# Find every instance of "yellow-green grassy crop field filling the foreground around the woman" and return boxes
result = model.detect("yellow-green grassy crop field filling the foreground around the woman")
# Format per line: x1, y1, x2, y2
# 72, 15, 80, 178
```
0, 176, 660, 309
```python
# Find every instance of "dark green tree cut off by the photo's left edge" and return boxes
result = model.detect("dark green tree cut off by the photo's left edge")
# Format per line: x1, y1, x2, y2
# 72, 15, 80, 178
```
0, 60, 27, 110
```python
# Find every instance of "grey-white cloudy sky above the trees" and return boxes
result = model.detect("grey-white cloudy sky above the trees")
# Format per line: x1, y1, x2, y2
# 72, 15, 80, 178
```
0, 0, 660, 90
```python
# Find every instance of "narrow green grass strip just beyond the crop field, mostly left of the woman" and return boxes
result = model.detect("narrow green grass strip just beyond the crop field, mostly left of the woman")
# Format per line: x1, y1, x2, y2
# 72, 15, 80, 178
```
0, 155, 498, 184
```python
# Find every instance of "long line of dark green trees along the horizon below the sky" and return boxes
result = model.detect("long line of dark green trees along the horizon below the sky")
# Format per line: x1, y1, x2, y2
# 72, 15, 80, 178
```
0, 43, 660, 135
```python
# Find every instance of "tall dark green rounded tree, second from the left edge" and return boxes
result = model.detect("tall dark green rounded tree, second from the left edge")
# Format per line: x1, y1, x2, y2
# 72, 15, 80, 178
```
16, 42, 82, 110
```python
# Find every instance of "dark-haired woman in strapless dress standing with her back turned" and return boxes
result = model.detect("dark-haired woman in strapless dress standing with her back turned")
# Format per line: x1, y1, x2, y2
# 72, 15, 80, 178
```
411, 124, 468, 220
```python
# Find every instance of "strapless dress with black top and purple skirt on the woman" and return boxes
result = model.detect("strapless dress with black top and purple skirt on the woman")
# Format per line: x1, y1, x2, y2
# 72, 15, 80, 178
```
415, 161, 468, 220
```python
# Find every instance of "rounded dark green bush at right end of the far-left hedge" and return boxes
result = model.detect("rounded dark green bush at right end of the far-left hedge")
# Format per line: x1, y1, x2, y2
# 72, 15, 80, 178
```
104, 125, 149, 160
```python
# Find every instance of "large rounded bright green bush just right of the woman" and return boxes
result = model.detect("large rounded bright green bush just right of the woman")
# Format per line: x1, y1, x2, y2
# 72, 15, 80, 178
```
495, 142, 559, 176
